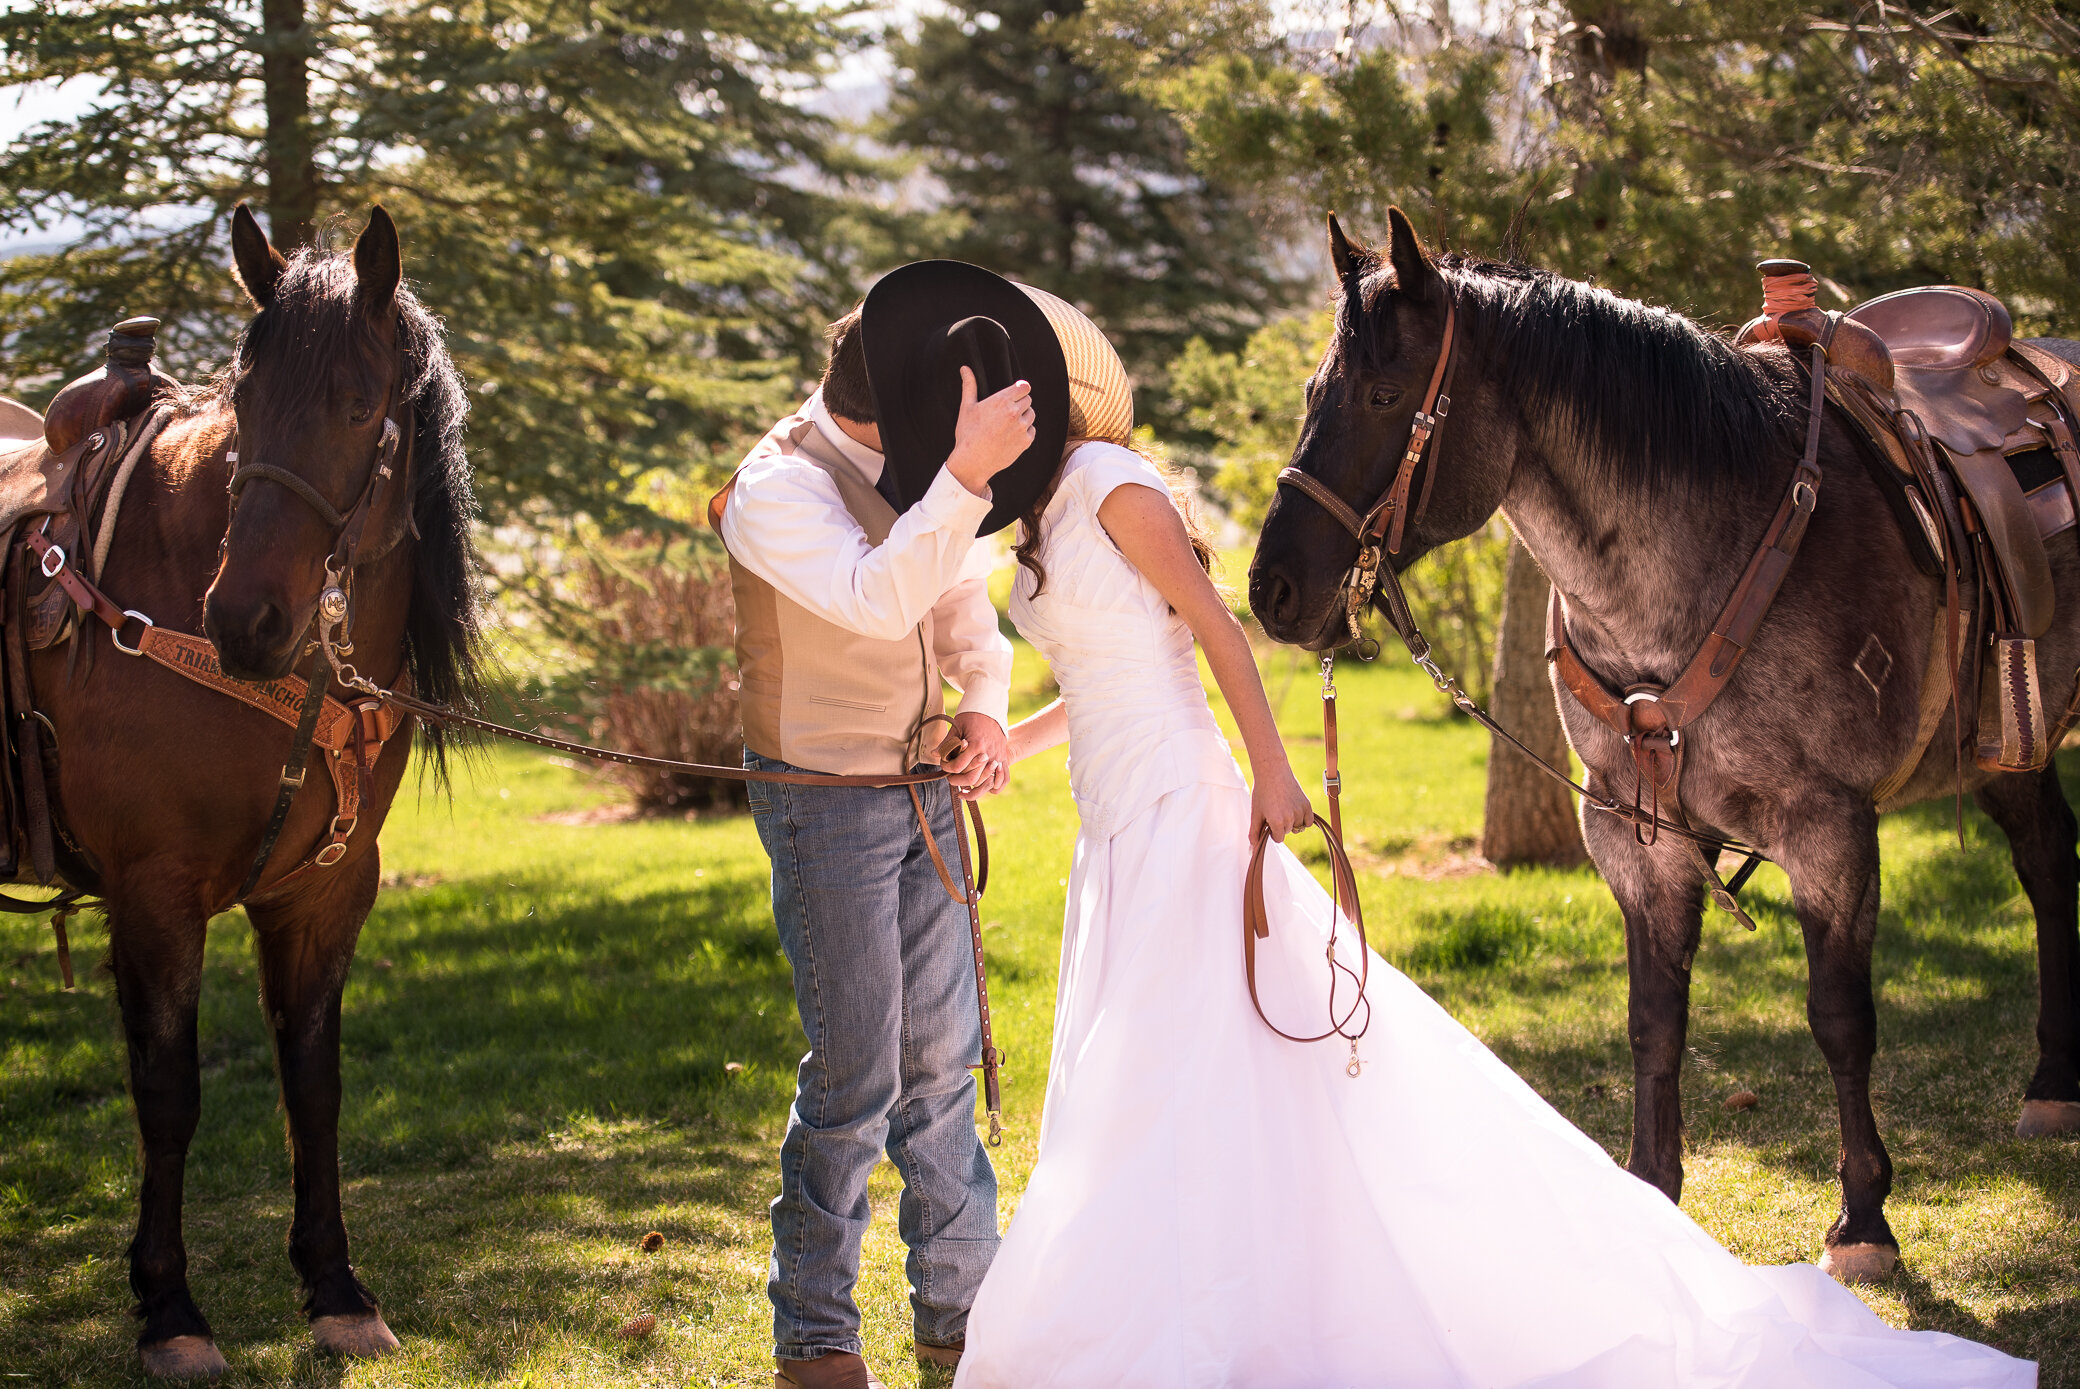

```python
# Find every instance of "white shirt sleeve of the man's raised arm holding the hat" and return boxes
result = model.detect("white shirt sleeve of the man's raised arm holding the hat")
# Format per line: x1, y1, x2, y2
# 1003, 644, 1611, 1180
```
722, 453, 1011, 644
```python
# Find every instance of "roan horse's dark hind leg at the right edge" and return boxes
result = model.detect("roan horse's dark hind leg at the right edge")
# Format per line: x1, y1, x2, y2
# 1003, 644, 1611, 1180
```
1978, 767, 2080, 1137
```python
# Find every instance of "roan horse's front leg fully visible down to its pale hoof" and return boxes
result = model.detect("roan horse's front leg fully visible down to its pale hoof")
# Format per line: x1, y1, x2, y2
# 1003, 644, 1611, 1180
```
1776, 794, 1899, 1283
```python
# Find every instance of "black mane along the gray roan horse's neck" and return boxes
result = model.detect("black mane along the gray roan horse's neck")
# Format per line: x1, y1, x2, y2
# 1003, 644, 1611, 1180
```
1347, 256, 1805, 493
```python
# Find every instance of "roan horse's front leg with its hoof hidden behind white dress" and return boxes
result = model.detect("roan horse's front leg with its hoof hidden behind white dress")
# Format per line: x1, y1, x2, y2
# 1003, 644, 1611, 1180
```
1583, 815, 1704, 1202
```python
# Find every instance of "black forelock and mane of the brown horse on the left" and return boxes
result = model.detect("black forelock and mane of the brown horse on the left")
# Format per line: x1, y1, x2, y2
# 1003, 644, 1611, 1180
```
201, 247, 485, 780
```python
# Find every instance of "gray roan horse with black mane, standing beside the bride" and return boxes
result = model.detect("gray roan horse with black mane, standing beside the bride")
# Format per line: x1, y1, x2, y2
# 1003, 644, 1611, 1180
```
1250, 210, 2080, 1279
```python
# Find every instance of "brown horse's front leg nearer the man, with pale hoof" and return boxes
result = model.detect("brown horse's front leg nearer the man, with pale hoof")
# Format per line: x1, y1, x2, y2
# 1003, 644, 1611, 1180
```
245, 853, 397, 1356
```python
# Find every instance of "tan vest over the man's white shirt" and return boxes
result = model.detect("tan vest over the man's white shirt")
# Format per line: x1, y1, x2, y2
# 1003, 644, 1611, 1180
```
709, 420, 946, 776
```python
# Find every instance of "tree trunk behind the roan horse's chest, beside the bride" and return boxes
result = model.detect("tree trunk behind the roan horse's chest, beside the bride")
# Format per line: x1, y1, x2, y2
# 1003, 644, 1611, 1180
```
1481, 534, 1589, 867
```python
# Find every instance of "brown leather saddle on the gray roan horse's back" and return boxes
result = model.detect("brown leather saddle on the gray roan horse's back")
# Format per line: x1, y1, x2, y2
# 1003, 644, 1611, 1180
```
1739, 260, 2080, 781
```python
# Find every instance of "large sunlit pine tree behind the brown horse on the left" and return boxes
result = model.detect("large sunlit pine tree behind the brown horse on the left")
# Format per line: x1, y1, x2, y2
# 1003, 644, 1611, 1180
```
0, 0, 865, 518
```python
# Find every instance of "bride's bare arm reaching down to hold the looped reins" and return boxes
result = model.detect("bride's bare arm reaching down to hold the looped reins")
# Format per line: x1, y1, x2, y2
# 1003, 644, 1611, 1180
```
1098, 482, 1315, 840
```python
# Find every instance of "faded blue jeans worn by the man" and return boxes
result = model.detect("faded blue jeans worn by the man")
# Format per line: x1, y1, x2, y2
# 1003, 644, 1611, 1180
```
745, 751, 998, 1360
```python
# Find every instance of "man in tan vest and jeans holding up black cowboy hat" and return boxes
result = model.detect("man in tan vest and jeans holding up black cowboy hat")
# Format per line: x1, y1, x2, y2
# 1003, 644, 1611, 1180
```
709, 262, 1067, 1389
